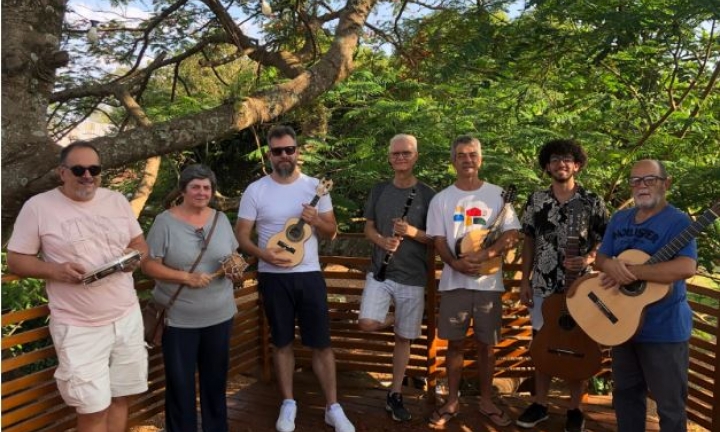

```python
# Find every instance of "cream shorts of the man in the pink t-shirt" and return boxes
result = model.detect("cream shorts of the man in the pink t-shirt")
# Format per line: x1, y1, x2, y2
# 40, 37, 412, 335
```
49, 306, 148, 414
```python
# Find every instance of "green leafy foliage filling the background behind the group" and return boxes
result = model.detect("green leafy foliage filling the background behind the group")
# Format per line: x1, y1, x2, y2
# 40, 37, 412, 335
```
54, 0, 720, 272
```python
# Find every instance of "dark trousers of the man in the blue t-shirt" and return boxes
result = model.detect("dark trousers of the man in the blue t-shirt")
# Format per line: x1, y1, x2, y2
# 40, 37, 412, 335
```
612, 342, 690, 432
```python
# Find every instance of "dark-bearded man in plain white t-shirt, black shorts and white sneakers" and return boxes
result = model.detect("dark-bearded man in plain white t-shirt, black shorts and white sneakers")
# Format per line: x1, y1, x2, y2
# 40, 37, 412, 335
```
235, 126, 355, 432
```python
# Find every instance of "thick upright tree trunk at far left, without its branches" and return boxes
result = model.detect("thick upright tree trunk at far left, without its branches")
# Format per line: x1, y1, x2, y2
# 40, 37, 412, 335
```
2, 0, 67, 244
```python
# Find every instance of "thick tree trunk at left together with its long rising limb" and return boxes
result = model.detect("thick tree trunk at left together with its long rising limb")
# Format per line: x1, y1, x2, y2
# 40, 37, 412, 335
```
2, 0, 377, 243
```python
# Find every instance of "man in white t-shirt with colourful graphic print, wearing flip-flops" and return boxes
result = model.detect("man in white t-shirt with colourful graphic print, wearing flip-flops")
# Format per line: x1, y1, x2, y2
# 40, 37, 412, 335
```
427, 135, 520, 427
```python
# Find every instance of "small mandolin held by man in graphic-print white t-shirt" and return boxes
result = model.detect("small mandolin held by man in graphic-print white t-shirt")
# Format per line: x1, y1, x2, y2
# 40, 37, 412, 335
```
455, 185, 517, 275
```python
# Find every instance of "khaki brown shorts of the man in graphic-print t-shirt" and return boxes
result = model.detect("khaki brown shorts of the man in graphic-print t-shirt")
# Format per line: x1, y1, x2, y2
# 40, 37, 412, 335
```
438, 288, 503, 345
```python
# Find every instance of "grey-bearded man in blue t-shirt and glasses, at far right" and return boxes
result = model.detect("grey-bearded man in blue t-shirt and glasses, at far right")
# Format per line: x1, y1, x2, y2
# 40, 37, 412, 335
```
597, 160, 697, 432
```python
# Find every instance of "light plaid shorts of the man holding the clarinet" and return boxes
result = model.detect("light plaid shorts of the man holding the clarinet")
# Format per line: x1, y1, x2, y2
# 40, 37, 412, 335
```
360, 273, 425, 339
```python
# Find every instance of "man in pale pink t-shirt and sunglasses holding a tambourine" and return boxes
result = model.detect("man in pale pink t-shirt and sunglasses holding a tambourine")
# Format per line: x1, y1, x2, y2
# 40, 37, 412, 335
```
7, 141, 148, 432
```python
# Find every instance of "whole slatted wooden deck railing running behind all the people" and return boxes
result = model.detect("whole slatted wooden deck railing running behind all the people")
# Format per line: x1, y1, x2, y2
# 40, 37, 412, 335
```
2, 250, 720, 432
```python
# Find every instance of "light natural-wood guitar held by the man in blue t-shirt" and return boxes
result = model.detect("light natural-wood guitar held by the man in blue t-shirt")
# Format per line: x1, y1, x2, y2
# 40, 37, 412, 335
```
568, 202, 720, 346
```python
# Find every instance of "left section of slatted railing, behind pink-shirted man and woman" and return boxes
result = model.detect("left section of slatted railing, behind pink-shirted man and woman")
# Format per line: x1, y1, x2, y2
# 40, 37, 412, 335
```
1, 272, 269, 432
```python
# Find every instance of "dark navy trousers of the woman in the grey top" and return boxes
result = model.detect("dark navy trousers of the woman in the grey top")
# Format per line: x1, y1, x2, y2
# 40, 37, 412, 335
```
162, 319, 233, 432
